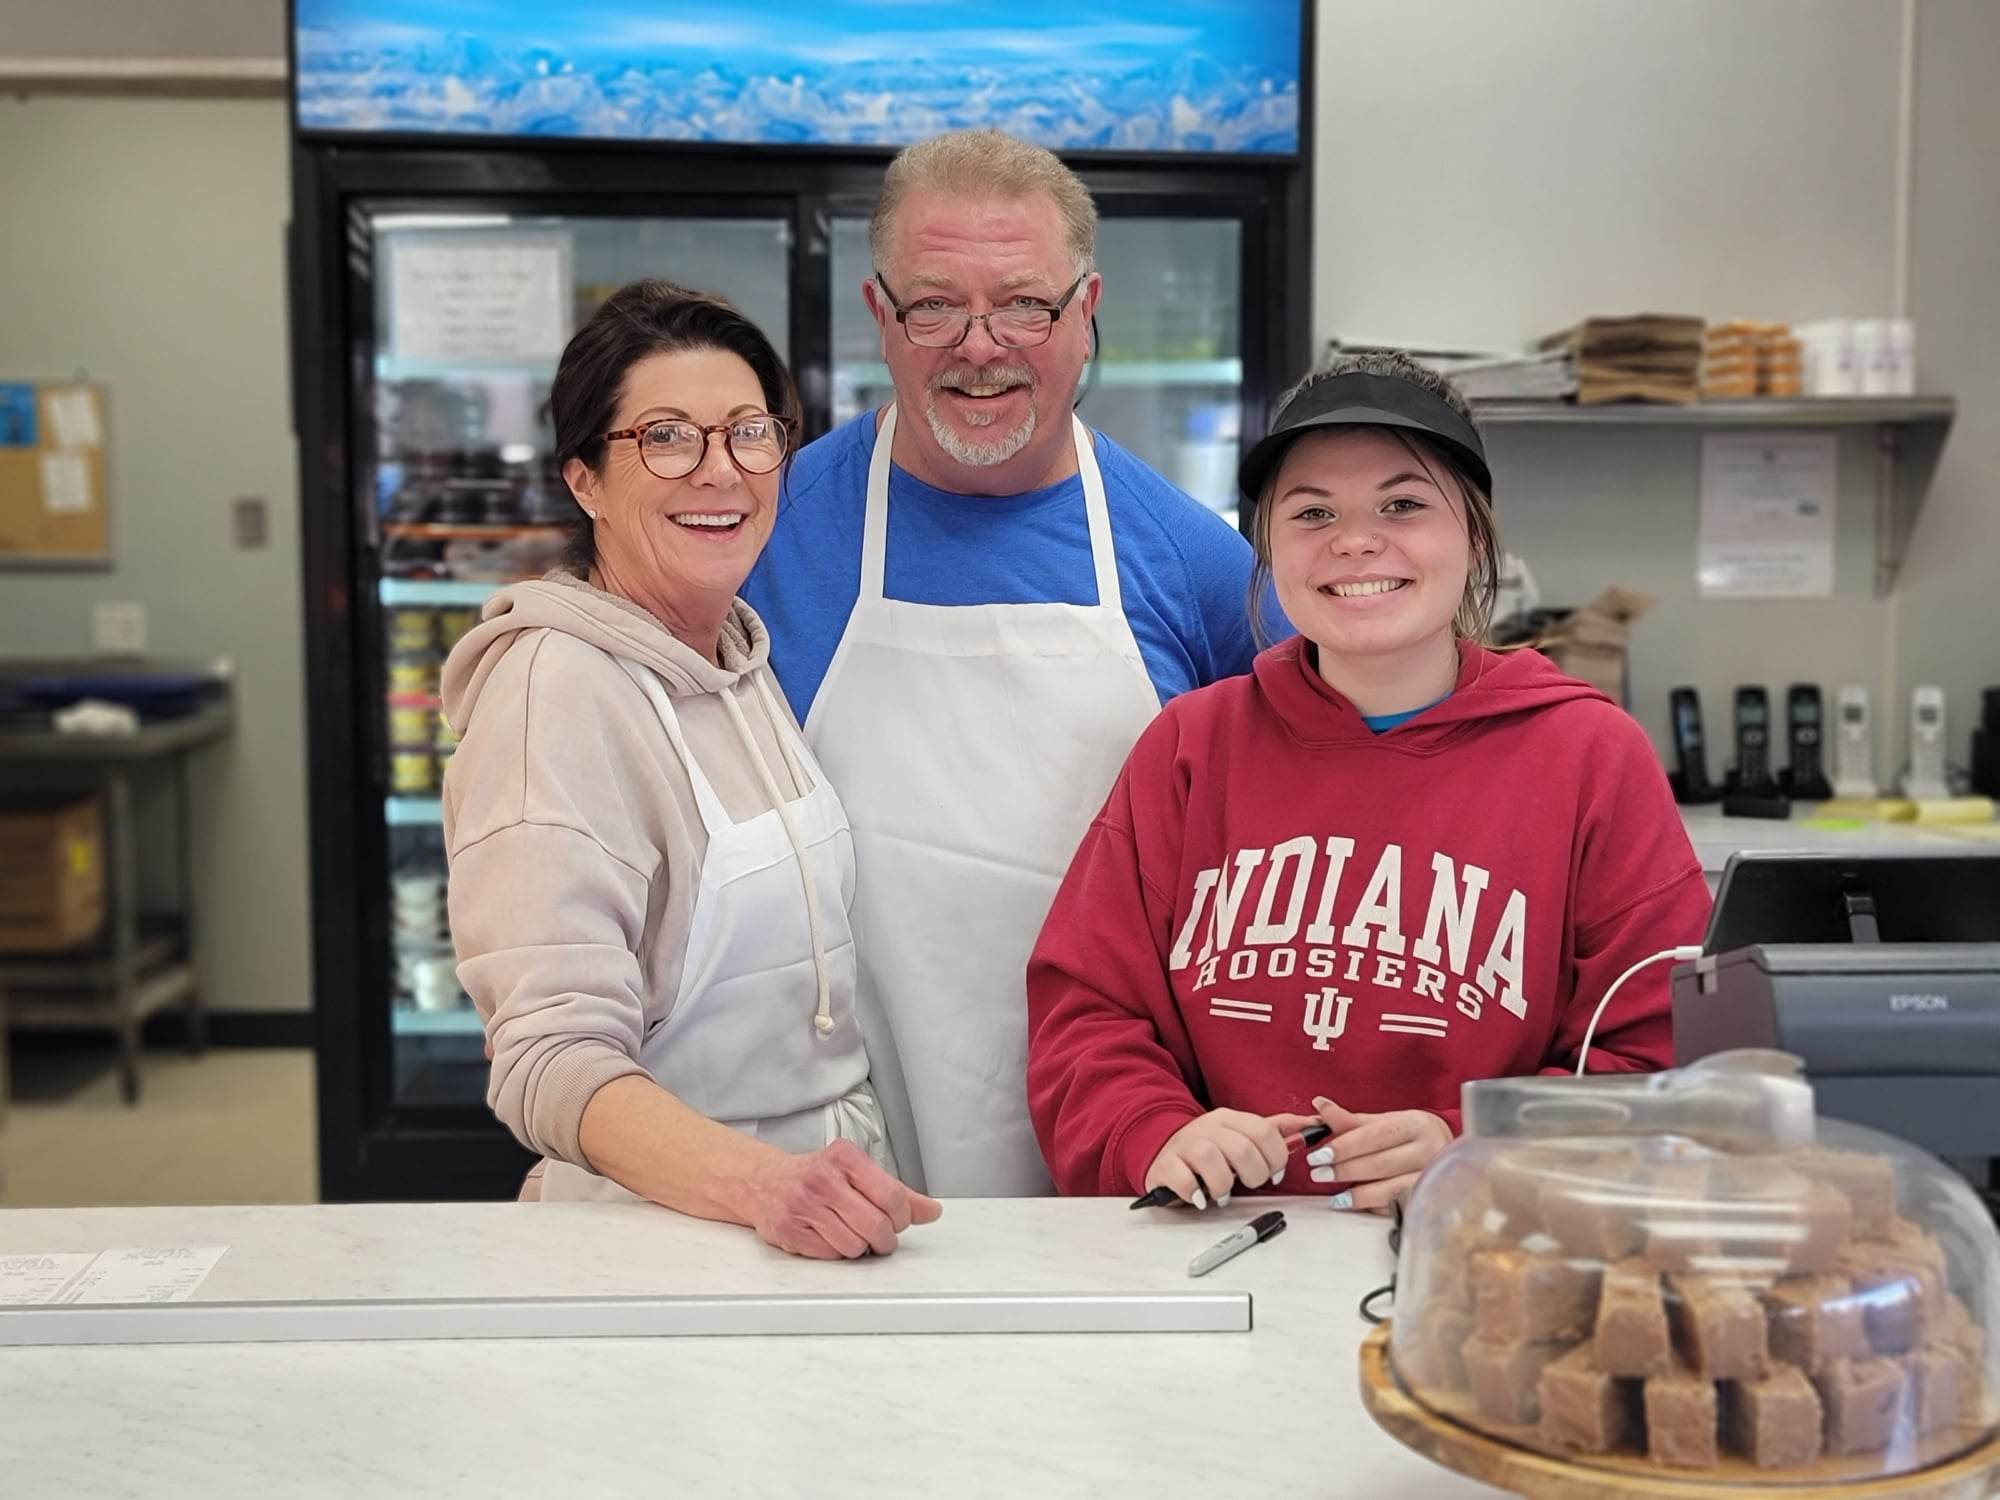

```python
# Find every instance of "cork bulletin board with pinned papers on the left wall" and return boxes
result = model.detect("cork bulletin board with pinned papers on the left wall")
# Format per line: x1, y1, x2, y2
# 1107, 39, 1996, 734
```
0, 380, 110, 566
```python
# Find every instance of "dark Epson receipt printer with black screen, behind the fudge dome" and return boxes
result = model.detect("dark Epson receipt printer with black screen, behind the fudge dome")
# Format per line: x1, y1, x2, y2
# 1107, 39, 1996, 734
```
1674, 846, 2000, 1186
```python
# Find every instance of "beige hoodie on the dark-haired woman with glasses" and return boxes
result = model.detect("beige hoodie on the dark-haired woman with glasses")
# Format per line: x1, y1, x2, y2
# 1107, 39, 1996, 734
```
444, 574, 806, 1168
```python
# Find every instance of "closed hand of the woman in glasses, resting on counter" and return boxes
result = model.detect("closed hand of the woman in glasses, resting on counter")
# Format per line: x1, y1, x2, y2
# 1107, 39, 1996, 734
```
750, 1140, 944, 1260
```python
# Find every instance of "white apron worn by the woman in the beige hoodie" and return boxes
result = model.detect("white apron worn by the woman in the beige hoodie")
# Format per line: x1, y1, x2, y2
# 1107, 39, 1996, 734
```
542, 662, 896, 1202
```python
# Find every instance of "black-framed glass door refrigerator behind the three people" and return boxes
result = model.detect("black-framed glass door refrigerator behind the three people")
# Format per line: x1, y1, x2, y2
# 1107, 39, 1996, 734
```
290, 0, 1310, 1200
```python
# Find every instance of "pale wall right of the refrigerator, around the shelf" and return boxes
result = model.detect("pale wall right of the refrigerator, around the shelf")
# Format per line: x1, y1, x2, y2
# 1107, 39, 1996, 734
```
1314, 0, 2000, 772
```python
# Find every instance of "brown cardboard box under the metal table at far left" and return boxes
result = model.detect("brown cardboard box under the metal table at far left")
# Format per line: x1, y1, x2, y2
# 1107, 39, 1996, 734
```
0, 798, 104, 954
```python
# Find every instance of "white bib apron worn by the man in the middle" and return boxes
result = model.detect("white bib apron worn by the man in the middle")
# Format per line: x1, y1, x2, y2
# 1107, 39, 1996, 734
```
806, 406, 1160, 1198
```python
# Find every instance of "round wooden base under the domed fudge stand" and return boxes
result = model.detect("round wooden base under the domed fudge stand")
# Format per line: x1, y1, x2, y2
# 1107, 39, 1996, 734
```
1360, 1324, 2000, 1500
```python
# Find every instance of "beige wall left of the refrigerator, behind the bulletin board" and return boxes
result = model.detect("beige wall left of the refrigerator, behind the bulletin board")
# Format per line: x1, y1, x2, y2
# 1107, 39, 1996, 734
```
0, 98, 310, 1010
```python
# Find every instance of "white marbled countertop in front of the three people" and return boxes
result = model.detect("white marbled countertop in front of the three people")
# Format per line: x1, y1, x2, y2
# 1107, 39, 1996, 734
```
0, 1198, 1496, 1500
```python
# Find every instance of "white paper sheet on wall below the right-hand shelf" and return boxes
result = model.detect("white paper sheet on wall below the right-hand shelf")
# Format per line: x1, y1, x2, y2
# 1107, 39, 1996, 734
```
1694, 432, 1840, 598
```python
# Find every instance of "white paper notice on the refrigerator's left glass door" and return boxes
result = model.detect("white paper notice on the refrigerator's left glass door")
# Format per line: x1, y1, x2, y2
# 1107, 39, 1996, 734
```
390, 236, 570, 360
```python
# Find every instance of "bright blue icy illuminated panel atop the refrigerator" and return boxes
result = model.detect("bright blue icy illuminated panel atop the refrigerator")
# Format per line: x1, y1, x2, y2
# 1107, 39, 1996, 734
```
296, 0, 1300, 152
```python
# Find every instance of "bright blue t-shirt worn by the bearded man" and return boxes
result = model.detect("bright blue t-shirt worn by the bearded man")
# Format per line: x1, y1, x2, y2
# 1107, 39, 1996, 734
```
742, 412, 1256, 724
